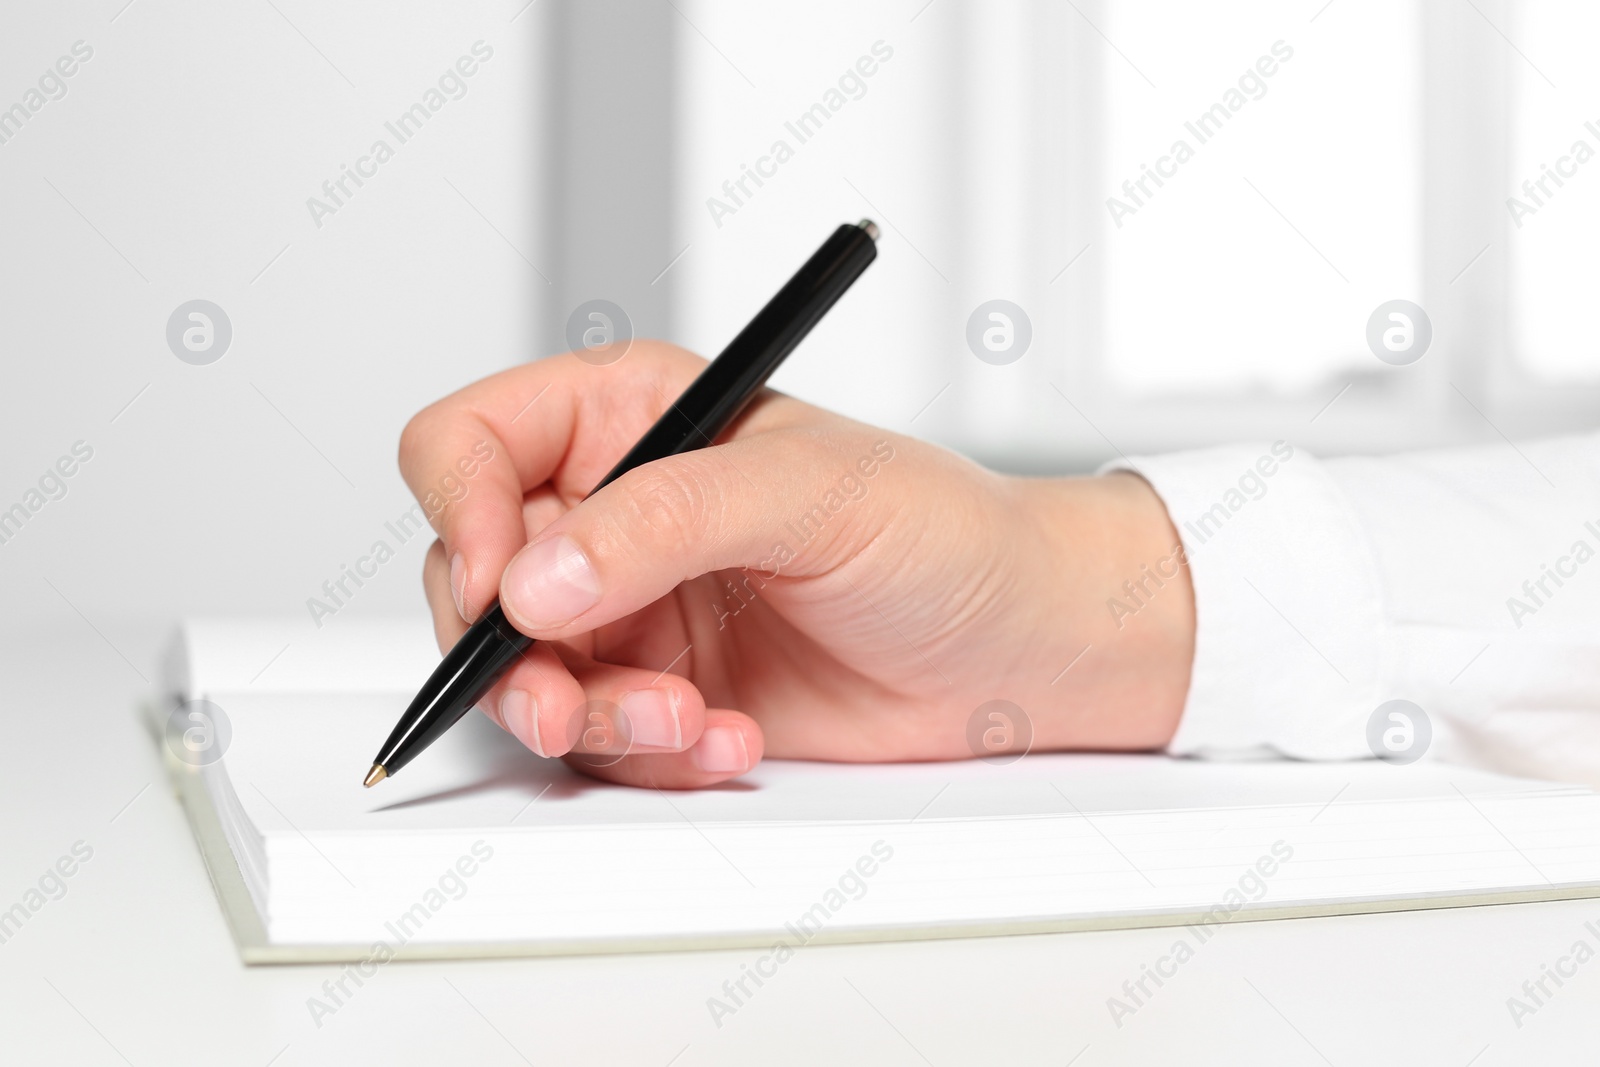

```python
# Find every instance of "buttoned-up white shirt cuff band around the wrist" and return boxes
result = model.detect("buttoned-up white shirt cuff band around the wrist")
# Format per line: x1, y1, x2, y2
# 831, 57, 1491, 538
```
1104, 442, 1397, 760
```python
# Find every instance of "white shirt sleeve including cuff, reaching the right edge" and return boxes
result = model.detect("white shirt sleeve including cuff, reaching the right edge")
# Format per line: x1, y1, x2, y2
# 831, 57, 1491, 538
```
1112, 435, 1600, 782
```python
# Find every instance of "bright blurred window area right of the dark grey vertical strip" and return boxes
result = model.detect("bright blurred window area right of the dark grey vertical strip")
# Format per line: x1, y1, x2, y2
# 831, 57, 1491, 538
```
674, 0, 1600, 470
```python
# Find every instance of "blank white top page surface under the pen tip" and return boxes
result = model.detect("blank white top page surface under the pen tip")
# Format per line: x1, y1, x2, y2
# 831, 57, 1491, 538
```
211, 693, 1582, 833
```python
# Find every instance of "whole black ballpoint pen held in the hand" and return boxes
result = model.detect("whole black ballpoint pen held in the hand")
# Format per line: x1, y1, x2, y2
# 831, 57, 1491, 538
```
363, 219, 878, 789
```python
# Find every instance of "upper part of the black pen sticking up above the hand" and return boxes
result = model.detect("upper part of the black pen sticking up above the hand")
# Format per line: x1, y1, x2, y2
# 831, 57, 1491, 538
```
590, 224, 878, 493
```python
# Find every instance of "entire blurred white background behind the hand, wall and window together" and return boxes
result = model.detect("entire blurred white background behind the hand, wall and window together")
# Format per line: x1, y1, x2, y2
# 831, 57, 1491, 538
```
0, 0, 1600, 645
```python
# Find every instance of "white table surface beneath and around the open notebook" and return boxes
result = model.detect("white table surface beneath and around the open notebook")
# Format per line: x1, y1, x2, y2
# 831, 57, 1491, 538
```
0, 625, 1600, 1067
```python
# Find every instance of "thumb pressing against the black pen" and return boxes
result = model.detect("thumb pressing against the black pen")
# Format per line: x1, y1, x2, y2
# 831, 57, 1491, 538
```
501, 432, 894, 640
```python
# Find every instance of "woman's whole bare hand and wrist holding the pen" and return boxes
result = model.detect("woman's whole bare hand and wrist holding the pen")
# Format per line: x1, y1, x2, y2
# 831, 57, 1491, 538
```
400, 341, 1194, 789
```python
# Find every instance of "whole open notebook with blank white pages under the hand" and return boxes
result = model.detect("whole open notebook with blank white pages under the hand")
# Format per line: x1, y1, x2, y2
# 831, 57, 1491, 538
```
157, 619, 1600, 963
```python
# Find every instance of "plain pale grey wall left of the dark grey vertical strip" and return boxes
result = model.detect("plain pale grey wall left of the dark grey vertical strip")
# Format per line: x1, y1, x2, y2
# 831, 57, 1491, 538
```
0, 0, 542, 633
